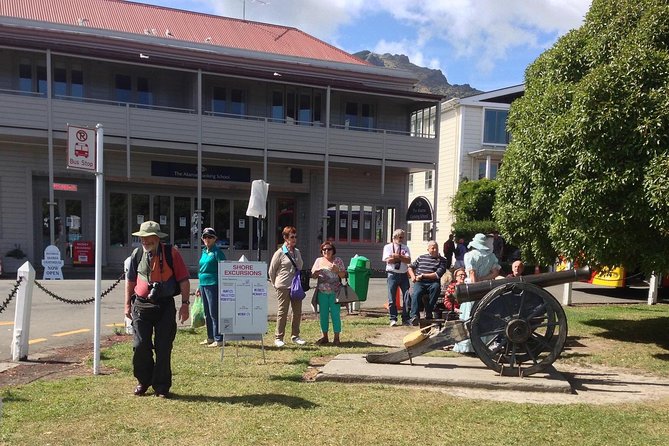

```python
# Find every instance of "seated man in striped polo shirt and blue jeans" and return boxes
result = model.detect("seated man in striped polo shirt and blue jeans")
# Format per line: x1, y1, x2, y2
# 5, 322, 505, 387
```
409, 240, 446, 325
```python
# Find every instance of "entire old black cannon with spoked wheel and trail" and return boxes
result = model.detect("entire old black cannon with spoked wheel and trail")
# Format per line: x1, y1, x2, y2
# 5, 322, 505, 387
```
366, 267, 590, 377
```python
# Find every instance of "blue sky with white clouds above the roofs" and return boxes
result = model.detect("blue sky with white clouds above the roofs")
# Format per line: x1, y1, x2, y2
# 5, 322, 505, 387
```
135, 0, 591, 91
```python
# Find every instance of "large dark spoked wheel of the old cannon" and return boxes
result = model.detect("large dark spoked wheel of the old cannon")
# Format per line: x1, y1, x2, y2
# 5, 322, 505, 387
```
470, 282, 567, 376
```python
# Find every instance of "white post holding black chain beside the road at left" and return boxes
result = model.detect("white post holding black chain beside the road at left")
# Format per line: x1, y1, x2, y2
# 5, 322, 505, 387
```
12, 262, 35, 361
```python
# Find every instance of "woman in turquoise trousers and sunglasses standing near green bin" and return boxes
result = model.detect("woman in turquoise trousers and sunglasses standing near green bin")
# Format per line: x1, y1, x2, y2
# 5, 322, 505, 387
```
311, 242, 346, 345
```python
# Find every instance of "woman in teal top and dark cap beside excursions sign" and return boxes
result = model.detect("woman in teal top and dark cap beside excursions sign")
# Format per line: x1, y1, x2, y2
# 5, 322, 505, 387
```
195, 228, 225, 347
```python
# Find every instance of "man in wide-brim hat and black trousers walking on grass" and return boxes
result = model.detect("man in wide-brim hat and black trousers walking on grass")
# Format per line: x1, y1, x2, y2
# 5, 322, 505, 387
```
125, 221, 190, 398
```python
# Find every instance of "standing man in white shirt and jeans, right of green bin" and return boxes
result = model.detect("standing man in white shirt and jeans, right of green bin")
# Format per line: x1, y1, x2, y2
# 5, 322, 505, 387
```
383, 229, 411, 327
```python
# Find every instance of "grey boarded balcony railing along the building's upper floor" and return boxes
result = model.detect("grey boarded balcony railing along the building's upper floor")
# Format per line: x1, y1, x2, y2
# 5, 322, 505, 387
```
0, 90, 438, 164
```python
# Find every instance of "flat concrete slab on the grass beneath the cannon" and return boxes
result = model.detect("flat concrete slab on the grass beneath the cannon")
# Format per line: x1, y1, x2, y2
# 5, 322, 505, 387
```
316, 354, 572, 393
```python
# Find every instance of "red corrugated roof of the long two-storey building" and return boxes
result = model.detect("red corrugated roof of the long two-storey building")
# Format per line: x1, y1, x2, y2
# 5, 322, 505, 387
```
0, 0, 368, 65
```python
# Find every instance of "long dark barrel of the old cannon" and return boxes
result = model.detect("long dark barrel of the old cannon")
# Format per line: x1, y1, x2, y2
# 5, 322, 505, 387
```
455, 266, 591, 303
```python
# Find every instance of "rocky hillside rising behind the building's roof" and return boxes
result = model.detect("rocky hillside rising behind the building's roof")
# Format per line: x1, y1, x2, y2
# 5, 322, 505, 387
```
353, 50, 481, 99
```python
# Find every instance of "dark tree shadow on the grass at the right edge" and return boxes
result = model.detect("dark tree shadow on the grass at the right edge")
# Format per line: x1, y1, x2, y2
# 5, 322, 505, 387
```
582, 317, 669, 350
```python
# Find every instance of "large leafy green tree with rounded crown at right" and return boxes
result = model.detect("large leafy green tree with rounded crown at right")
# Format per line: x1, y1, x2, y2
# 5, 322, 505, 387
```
494, 0, 669, 272
